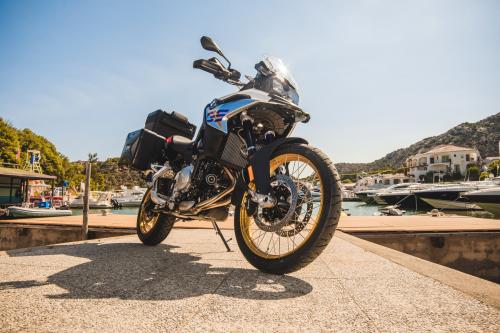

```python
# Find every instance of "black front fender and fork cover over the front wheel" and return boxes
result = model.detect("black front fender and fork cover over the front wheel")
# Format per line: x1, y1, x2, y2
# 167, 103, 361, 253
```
231, 137, 308, 206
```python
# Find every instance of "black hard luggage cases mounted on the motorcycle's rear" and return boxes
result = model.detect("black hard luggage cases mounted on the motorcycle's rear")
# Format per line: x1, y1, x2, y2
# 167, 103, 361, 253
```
119, 110, 196, 170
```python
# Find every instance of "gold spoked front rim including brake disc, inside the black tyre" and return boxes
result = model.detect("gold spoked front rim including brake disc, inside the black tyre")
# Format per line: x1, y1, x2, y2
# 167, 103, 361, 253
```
240, 153, 324, 258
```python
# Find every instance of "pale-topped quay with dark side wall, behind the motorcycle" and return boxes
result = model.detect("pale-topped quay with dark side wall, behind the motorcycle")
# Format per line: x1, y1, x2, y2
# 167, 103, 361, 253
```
0, 214, 500, 283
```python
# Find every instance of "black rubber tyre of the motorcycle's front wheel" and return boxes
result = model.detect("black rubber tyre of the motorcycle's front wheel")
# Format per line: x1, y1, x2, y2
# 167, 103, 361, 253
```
234, 144, 342, 274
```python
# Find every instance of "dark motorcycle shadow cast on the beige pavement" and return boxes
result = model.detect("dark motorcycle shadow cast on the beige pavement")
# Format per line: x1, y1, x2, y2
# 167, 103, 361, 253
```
0, 243, 313, 300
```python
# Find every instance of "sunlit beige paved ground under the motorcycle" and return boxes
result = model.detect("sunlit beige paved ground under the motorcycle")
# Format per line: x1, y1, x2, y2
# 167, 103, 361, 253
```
0, 229, 500, 332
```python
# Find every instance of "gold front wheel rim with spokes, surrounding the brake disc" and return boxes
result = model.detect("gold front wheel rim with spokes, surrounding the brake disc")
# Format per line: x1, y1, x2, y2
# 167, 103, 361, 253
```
239, 153, 324, 259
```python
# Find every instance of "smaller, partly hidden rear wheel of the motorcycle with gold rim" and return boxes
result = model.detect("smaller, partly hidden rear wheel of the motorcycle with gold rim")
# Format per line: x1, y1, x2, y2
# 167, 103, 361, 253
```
136, 190, 175, 246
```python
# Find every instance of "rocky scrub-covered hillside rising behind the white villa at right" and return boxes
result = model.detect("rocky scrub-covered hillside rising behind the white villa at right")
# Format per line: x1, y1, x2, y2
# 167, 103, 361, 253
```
336, 112, 500, 174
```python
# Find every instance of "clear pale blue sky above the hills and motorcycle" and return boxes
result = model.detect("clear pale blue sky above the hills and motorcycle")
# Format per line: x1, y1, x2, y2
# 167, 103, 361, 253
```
0, 0, 500, 162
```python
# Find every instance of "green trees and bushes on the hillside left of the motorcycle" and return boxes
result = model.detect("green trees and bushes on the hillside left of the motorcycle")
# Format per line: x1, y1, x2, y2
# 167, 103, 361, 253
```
0, 118, 144, 190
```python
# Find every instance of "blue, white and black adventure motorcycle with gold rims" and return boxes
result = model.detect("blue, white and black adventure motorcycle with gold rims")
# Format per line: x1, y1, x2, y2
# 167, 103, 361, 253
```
121, 37, 341, 274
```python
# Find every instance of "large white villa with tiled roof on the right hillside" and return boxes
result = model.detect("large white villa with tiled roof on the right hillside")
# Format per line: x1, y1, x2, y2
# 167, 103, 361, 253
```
405, 145, 481, 181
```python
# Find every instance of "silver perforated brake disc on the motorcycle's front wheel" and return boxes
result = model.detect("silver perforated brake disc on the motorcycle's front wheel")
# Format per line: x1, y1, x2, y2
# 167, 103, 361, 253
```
254, 175, 298, 232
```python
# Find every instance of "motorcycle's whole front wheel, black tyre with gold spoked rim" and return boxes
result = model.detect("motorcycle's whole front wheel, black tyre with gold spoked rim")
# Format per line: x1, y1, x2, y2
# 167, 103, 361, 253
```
234, 144, 342, 274
